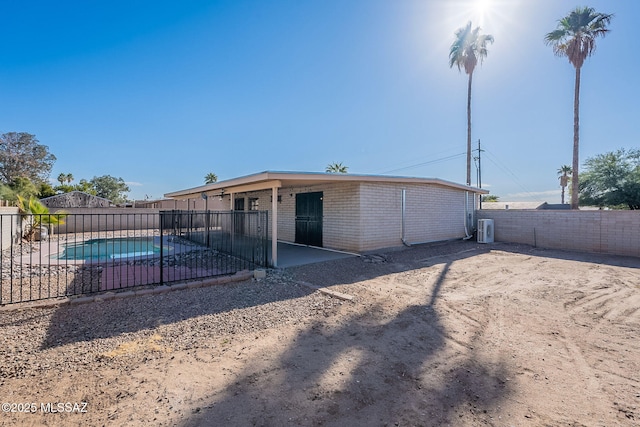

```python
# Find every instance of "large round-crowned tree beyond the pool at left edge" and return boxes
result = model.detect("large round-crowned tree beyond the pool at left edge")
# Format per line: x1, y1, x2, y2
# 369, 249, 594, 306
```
0, 132, 56, 185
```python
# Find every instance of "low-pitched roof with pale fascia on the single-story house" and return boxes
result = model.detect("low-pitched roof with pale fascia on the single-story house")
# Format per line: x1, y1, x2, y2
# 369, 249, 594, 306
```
164, 171, 489, 200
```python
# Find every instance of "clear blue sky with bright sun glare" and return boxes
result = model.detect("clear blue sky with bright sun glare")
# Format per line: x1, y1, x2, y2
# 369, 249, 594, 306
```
0, 0, 640, 203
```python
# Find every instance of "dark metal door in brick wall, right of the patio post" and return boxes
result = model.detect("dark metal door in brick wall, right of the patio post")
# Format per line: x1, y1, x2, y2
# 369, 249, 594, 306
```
296, 191, 322, 247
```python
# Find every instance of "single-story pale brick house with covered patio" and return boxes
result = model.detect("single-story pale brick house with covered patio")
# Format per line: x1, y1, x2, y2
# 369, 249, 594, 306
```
165, 171, 488, 266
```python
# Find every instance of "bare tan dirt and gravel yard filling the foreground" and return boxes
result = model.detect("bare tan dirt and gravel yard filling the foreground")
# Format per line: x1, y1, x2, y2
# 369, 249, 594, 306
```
0, 242, 640, 426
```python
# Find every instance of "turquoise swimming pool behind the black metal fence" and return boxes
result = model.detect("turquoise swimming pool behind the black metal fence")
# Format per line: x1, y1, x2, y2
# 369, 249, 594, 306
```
55, 237, 172, 261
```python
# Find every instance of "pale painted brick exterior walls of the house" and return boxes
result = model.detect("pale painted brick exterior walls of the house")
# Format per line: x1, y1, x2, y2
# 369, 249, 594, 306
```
227, 182, 473, 252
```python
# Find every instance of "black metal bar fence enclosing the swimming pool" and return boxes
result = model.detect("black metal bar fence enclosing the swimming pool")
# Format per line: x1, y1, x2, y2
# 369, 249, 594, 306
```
0, 211, 268, 305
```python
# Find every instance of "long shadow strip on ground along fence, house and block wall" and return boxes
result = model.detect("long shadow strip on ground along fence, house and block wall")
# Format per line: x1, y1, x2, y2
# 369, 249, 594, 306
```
41, 241, 640, 356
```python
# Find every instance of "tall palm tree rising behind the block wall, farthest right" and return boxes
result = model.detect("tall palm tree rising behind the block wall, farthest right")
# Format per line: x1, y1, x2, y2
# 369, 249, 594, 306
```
544, 7, 613, 209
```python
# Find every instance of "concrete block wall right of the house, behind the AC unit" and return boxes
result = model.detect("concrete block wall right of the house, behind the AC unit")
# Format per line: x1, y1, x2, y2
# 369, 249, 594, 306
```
478, 210, 640, 256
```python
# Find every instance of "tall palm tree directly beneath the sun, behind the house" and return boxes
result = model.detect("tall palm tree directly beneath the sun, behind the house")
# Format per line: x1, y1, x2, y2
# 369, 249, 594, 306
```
449, 21, 493, 185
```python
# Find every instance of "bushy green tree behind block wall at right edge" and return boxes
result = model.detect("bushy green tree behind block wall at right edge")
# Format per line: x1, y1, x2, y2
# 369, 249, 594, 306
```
580, 149, 640, 210
